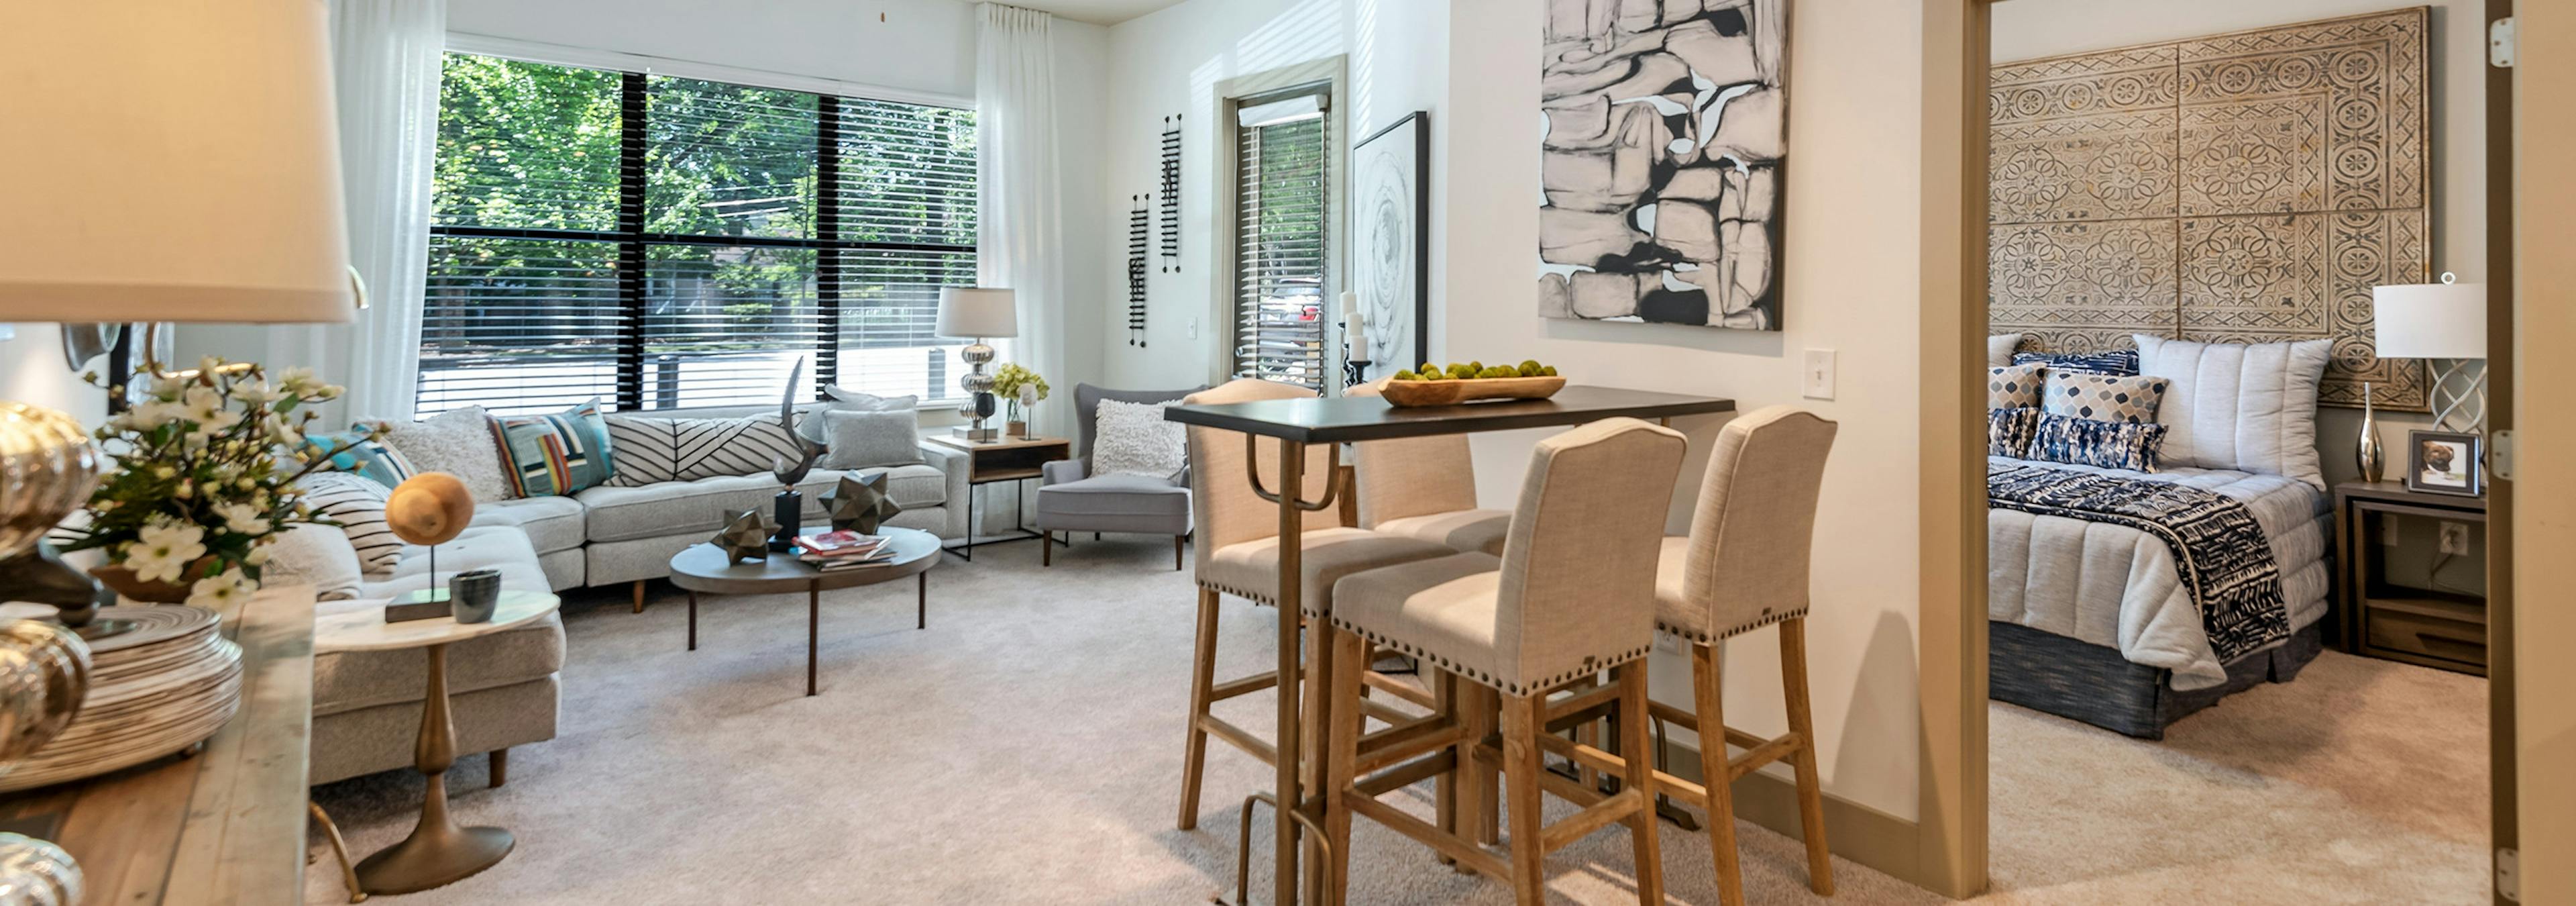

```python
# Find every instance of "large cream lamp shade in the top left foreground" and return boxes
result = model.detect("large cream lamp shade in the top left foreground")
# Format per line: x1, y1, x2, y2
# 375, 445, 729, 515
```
0, 0, 356, 321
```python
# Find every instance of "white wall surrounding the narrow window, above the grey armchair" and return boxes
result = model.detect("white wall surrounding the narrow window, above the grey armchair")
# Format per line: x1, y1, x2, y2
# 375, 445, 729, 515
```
1095, 0, 1448, 389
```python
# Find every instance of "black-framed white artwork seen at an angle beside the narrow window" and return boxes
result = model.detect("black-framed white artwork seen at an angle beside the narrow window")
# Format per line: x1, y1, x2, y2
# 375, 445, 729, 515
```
1350, 111, 1432, 381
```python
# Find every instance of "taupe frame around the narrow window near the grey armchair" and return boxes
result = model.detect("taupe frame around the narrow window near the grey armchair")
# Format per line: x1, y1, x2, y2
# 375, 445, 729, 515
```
1198, 56, 1350, 397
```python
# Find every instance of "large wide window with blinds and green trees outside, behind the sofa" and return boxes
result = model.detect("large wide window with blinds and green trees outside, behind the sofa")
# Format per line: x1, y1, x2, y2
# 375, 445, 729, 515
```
420, 54, 976, 414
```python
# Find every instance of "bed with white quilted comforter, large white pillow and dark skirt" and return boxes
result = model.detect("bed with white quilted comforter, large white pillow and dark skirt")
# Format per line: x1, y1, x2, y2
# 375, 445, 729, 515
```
1986, 337, 2334, 739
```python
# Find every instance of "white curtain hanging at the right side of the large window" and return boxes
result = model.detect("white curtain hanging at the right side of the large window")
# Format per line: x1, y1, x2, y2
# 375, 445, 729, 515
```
974, 3, 1074, 438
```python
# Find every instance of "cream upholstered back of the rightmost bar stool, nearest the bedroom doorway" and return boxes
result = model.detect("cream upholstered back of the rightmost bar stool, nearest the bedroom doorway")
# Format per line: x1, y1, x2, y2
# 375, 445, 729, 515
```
1656, 407, 1837, 641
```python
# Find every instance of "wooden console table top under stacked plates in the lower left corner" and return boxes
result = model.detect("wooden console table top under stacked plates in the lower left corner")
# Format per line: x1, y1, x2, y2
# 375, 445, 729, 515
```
0, 587, 314, 906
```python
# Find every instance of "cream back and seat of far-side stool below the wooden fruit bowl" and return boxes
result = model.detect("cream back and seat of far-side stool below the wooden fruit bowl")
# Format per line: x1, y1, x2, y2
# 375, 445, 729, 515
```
1342, 383, 1512, 556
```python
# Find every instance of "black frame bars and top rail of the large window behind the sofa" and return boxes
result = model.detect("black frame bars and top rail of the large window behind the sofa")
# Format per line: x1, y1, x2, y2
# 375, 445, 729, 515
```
412, 34, 984, 412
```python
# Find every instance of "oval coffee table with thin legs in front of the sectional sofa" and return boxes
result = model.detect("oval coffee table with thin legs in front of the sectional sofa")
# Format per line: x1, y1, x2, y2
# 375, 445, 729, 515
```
669, 527, 941, 695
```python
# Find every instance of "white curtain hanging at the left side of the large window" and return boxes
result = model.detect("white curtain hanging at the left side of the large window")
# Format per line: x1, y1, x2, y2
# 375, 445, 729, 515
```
263, 0, 448, 422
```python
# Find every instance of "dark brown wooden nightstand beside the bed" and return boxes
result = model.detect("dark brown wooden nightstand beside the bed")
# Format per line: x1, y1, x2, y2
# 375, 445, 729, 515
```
2334, 481, 2486, 677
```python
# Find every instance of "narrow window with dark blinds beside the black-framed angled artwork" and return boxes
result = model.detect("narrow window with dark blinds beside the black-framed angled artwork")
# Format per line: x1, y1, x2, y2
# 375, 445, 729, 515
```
1234, 85, 1332, 391
